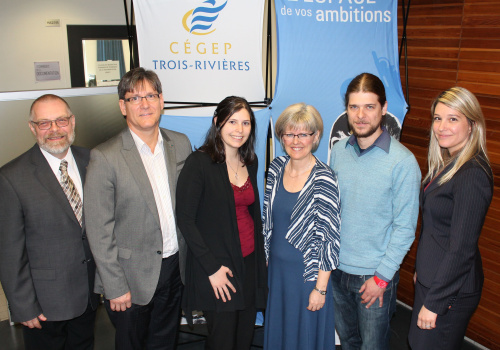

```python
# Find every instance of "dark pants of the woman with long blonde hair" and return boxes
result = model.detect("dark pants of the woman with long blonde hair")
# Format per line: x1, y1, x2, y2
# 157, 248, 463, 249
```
408, 282, 481, 350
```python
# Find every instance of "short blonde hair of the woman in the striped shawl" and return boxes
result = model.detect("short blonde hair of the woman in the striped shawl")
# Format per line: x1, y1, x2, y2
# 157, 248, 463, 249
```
274, 102, 323, 152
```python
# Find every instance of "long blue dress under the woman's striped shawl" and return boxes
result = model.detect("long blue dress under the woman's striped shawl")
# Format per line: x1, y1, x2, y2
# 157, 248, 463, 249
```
264, 181, 335, 350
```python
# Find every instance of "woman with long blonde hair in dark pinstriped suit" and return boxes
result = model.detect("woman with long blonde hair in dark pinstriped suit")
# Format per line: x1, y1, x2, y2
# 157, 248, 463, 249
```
409, 87, 493, 350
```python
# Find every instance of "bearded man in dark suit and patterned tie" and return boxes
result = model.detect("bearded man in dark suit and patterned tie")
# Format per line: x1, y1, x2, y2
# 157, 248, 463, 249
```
0, 95, 98, 350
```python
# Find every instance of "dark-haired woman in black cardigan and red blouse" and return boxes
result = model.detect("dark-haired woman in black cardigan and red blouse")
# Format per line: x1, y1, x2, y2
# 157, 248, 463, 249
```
176, 96, 267, 350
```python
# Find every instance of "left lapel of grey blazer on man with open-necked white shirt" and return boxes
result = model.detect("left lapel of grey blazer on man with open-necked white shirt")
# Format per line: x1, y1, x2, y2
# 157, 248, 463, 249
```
122, 128, 161, 226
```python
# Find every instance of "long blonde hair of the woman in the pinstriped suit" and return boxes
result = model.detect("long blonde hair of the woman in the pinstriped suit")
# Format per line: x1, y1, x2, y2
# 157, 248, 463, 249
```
423, 86, 489, 185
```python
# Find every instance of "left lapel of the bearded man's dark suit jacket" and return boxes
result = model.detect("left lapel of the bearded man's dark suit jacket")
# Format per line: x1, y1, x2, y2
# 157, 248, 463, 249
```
31, 145, 80, 226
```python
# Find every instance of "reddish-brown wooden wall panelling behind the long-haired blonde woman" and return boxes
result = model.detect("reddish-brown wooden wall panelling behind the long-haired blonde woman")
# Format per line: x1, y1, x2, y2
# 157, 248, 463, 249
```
398, 0, 500, 349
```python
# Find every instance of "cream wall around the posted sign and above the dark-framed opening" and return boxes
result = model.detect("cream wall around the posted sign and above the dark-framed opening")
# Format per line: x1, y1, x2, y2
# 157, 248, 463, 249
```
0, 0, 130, 92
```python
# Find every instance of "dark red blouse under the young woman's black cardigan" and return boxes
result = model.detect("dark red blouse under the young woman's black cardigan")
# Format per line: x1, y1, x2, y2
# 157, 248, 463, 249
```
231, 177, 255, 257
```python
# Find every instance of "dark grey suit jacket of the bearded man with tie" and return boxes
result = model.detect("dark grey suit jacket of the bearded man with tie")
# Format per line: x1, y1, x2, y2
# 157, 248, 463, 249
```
0, 145, 97, 322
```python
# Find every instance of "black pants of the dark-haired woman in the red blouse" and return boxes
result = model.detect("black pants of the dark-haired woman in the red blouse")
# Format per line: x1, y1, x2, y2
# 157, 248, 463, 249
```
203, 253, 257, 350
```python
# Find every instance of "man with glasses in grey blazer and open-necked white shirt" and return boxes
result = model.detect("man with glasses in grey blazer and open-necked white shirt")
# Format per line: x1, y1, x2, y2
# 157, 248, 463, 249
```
85, 68, 191, 349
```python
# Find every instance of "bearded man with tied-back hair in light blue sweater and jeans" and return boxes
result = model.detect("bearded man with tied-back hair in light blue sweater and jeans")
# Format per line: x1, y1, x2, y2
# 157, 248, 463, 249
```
330, 73, 421, 350
